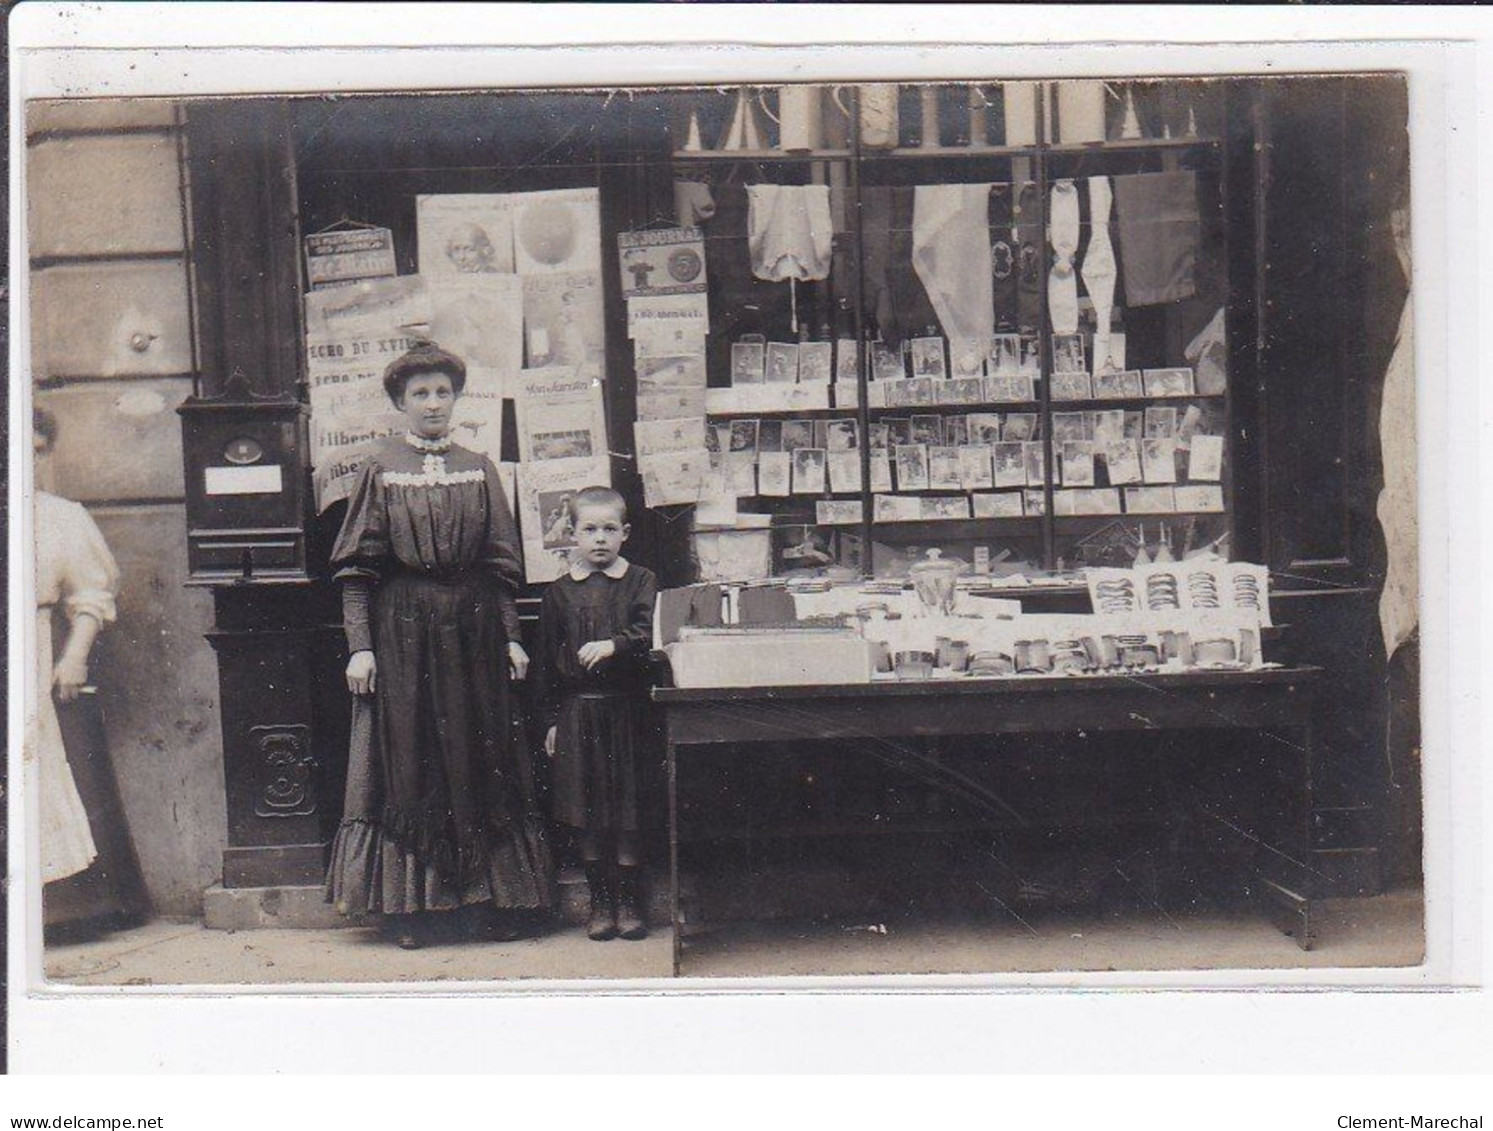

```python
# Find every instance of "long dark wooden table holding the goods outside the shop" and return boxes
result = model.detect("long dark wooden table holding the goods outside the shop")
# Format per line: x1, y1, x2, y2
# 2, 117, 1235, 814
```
652, 667, 1321, 976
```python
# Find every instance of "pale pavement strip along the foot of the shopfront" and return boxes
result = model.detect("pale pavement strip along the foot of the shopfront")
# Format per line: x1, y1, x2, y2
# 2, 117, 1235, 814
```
45, 891, 1424, 986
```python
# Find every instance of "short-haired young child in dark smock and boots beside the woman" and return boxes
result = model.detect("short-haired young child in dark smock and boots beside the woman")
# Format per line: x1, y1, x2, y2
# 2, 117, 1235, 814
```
537, 486, 658, 942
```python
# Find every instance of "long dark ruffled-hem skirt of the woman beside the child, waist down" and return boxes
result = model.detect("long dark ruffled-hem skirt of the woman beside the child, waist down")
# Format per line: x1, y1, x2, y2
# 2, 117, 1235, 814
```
325, 574, 552, 915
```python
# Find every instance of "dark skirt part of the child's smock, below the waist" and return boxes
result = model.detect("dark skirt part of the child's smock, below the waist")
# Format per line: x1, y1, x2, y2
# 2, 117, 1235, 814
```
552, 691, 643, 833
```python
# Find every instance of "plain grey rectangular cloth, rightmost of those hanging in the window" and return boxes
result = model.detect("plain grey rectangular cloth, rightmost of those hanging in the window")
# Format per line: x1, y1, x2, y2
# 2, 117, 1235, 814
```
1115, 173, 1199, 306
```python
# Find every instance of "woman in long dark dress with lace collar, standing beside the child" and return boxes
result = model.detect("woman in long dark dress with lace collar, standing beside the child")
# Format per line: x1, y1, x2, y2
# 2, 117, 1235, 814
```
327, 345, 551, 947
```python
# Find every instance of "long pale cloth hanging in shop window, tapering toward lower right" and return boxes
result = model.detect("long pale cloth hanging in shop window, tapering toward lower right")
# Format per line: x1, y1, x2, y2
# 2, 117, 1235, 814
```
912, 185, 996, 342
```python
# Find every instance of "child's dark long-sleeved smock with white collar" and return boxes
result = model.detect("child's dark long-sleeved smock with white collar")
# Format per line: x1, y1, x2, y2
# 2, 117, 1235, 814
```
537, 558, 658, 833
